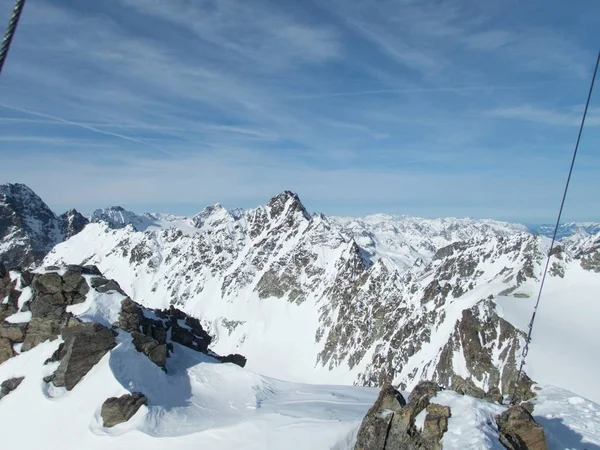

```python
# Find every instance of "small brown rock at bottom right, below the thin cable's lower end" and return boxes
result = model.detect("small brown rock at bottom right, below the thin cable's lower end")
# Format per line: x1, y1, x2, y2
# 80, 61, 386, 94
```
496, 405, 548, 450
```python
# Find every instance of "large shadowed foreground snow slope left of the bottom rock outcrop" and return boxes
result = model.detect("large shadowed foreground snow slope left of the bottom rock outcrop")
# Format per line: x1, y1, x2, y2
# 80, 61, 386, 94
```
0, 334, 377, 450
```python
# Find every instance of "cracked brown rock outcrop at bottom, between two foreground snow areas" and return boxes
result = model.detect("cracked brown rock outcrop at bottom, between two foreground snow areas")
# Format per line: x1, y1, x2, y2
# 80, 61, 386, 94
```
354, 381, 451, 450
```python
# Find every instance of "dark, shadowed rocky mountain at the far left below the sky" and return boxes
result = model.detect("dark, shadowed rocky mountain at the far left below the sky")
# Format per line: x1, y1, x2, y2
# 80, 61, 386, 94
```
0, 184, 88, 267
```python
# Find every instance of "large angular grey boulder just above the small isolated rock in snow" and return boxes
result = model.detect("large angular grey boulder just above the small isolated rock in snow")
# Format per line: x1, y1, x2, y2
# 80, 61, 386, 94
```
52, 322, 117, 391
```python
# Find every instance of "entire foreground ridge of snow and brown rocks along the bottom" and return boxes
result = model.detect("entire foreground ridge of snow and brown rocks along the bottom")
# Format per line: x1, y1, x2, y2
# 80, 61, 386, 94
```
0, 265, 600, 450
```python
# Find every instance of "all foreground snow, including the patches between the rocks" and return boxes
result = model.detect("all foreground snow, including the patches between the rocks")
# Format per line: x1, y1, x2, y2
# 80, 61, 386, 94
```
0, 282, 600, 450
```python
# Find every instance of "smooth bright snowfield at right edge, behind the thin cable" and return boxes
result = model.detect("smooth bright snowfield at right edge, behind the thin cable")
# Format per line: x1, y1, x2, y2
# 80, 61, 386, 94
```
495, 265, 600, 402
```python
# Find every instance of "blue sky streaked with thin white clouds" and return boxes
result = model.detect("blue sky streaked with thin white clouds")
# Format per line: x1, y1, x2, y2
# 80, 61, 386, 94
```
0, 0, 600, 222
